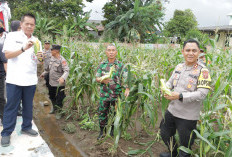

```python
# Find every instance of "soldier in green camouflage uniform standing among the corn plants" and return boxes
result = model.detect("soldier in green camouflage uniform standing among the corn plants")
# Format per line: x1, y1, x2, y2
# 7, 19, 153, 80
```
96, 44, 130, 139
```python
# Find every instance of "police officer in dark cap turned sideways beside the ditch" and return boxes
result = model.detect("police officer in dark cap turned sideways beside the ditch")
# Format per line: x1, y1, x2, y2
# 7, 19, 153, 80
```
40, 45, 69, 114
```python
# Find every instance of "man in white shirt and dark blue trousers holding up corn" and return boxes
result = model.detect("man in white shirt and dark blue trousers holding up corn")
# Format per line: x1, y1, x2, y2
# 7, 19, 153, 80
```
1, 14, 42, 147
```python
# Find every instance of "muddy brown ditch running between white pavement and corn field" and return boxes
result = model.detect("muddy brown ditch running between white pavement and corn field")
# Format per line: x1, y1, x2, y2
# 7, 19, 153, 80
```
34, 83, 87, 157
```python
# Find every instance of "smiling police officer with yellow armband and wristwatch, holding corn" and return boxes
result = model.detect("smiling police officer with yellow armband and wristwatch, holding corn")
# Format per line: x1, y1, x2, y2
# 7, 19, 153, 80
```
160, 39, 211, 157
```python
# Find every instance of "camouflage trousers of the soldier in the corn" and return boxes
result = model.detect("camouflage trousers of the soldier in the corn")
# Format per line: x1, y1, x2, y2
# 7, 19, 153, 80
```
98, 99, 115, 127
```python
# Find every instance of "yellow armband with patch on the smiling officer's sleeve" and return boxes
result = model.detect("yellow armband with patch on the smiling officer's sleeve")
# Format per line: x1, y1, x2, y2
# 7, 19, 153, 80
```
197, 68, 211, 89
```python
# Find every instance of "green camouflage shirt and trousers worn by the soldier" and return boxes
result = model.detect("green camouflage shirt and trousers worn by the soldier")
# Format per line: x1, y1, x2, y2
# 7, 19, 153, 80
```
96, 60, 127, 127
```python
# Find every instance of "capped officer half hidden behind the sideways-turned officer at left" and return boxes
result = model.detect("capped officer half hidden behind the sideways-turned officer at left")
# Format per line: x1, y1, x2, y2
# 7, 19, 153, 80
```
43, 40, 52, 105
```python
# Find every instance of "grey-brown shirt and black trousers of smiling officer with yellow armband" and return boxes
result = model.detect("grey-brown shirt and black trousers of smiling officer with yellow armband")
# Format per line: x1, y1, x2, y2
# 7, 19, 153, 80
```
160, 63, 211, 155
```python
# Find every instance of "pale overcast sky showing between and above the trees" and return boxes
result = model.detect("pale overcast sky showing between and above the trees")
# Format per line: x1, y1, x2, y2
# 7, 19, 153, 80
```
84, 0, 232, 27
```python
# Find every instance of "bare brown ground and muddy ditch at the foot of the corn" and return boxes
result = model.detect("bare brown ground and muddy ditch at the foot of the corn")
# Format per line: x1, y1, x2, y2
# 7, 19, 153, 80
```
34, 80, 167, 157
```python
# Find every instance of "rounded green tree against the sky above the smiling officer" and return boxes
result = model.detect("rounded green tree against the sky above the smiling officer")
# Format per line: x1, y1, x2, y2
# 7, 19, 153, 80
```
164, 9, 198, 37
